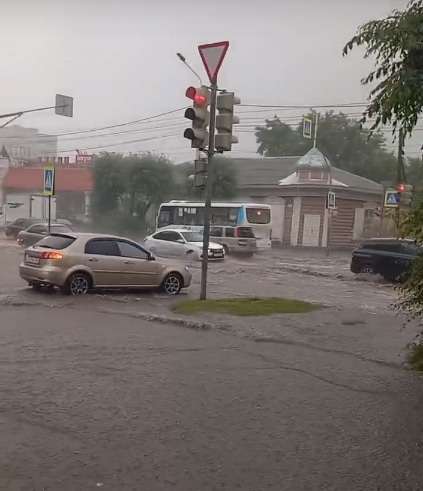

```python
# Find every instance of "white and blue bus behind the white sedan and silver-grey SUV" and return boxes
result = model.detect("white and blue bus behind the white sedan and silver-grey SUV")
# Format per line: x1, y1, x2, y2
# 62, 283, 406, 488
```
156, 200, 272, 250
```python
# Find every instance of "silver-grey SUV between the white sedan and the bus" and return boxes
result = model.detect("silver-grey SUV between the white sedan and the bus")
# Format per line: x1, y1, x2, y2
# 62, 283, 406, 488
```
210, 225, 257, 256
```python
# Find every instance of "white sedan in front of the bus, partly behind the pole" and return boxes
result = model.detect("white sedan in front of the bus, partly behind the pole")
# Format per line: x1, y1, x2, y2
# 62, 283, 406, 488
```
143, 227, 225, 260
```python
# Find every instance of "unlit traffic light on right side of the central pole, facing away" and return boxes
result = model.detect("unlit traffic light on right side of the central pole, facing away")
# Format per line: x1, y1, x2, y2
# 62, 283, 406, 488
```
215, 92, 241, 152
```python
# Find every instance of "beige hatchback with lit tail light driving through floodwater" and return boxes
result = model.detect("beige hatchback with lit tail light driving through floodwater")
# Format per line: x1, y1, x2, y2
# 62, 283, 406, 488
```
19, 232, 191, 295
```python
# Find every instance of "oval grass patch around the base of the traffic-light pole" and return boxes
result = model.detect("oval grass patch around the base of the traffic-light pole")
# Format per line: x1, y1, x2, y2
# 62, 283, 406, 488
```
173, 297, 319, 316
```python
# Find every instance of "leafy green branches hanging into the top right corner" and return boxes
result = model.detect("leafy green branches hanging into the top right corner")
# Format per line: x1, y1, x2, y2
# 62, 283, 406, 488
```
343, 0, 423, 135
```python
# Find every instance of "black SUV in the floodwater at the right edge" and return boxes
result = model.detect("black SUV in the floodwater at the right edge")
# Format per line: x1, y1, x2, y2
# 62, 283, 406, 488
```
351, 239, 423, 282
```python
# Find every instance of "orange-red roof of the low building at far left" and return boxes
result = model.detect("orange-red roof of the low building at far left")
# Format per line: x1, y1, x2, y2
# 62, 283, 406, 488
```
3, 167, 93, 193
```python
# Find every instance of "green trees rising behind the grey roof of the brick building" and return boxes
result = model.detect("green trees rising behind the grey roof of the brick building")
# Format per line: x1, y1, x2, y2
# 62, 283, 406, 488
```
256, 111, 396, 182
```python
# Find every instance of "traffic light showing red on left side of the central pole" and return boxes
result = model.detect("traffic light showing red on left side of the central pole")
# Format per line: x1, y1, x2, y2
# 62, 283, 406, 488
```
184, 86, 210, 148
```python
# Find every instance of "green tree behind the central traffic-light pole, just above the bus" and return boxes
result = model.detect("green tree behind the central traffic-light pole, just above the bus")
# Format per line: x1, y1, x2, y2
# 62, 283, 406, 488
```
175, 156, 237, 200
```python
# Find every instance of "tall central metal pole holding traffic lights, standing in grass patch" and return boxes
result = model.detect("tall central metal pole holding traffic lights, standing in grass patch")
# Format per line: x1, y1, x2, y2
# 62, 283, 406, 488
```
200, 82, 217, 300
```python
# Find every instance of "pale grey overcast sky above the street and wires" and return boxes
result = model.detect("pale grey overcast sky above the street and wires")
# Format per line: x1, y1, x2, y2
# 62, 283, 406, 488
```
0, 0, 420, 162
